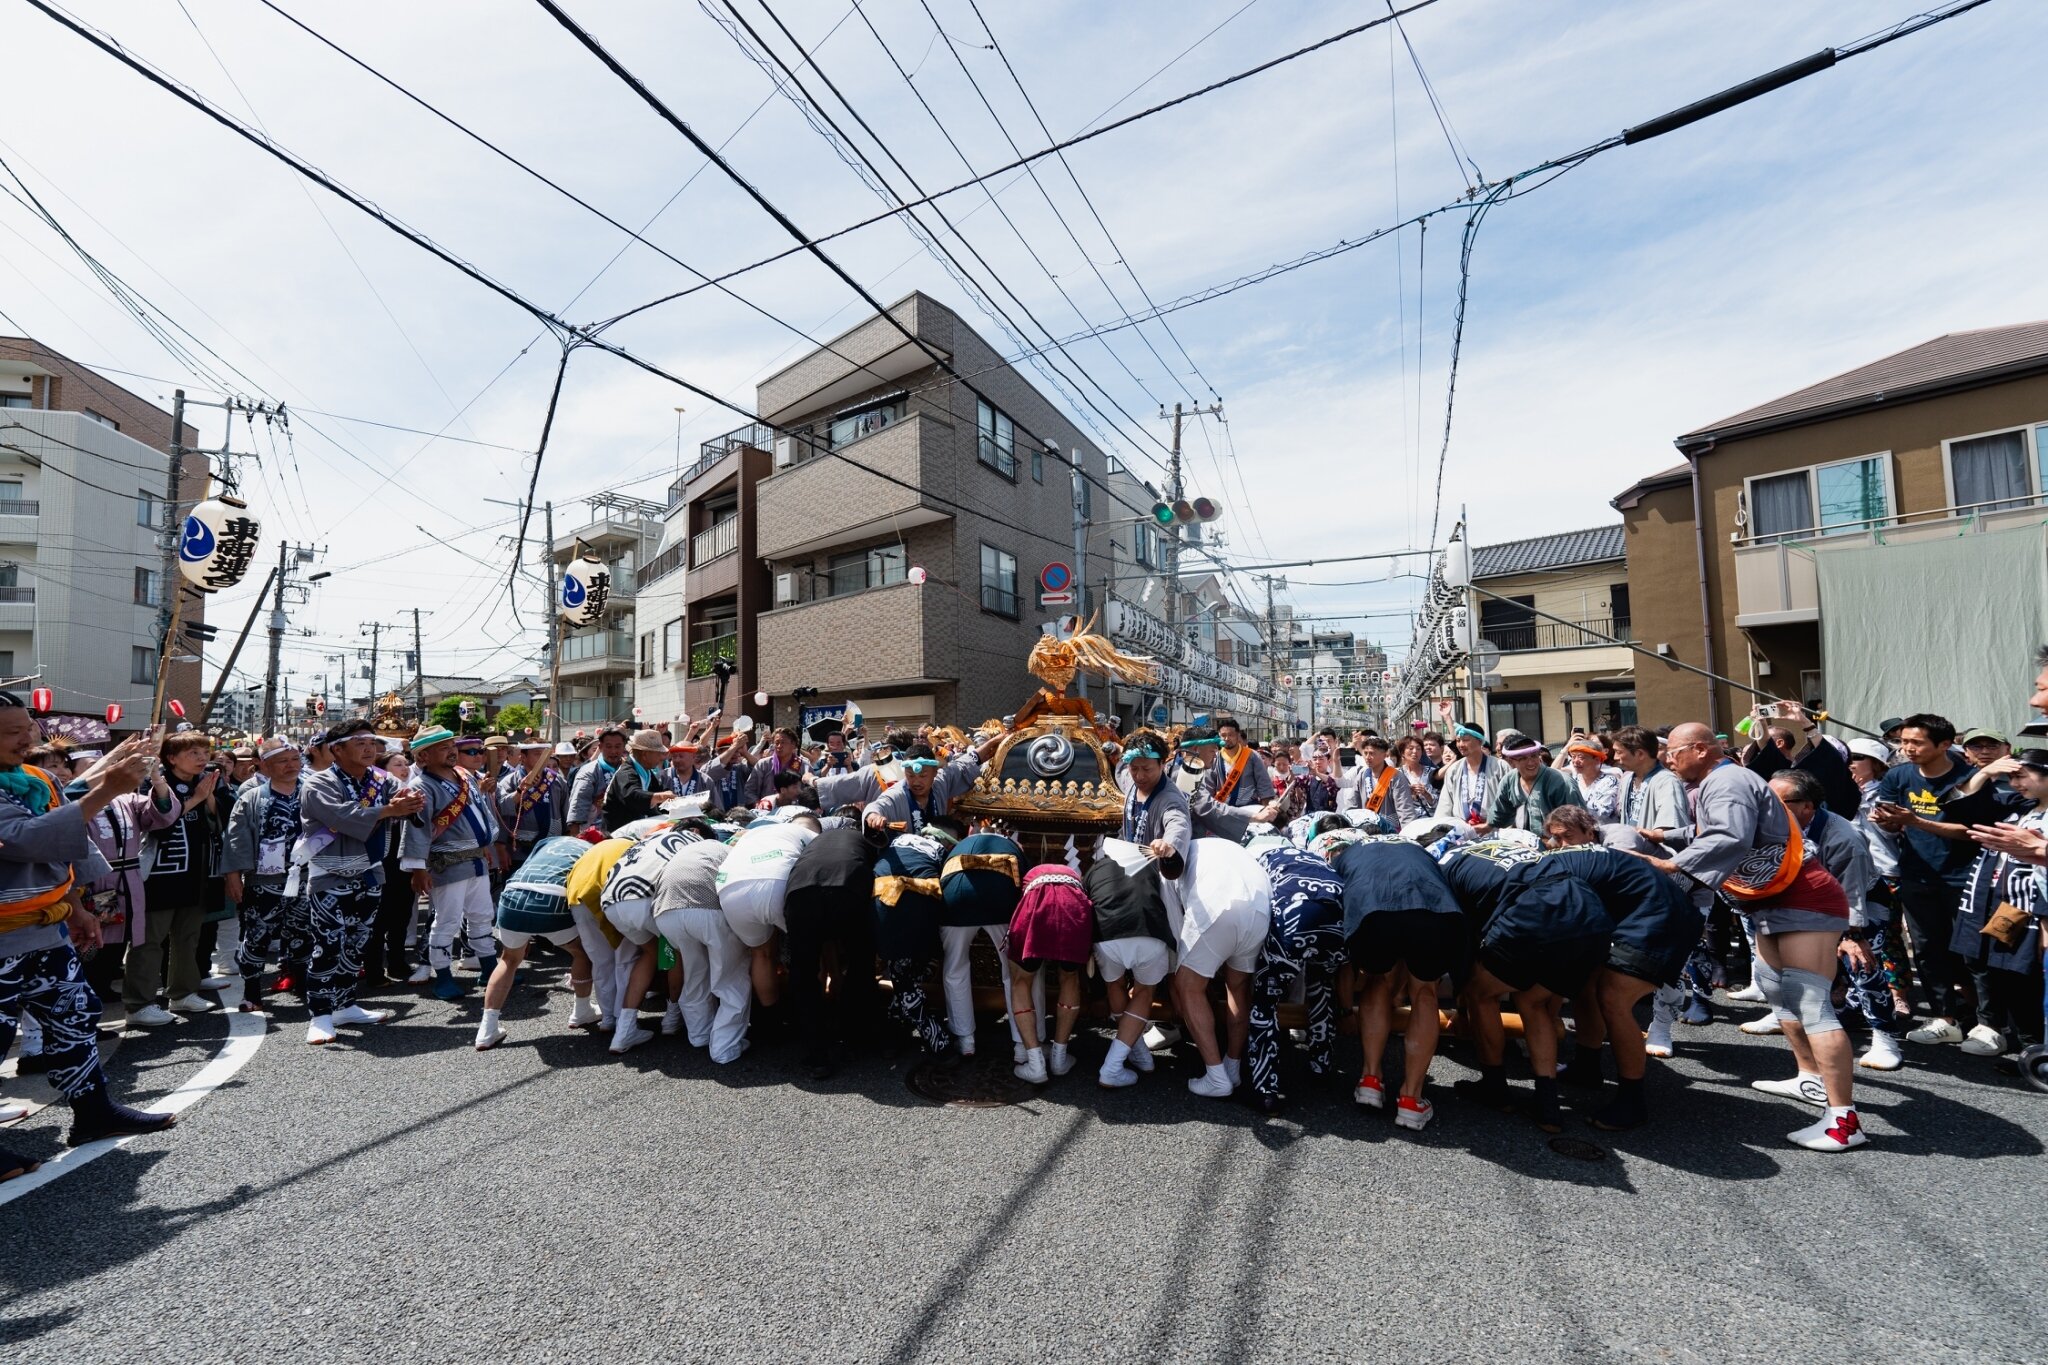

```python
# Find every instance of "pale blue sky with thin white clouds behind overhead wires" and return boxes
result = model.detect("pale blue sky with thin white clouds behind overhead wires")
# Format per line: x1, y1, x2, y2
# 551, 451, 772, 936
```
0, 0, 2048, 696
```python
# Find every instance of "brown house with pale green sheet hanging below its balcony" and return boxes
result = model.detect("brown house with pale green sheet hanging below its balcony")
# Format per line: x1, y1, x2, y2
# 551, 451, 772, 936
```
1614, 321, 2048, 731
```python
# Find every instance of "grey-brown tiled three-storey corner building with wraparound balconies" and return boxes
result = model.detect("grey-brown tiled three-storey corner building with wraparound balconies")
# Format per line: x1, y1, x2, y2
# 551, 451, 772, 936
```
741, 293, 1120, 729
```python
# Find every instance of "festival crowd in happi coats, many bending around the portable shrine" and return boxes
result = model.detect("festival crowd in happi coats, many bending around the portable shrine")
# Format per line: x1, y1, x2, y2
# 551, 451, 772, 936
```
0, 651, 2048, 1179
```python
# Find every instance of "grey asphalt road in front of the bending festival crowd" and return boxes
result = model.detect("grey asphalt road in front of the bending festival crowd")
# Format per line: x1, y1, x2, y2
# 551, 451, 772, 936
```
0, 974, 2048, 1365
